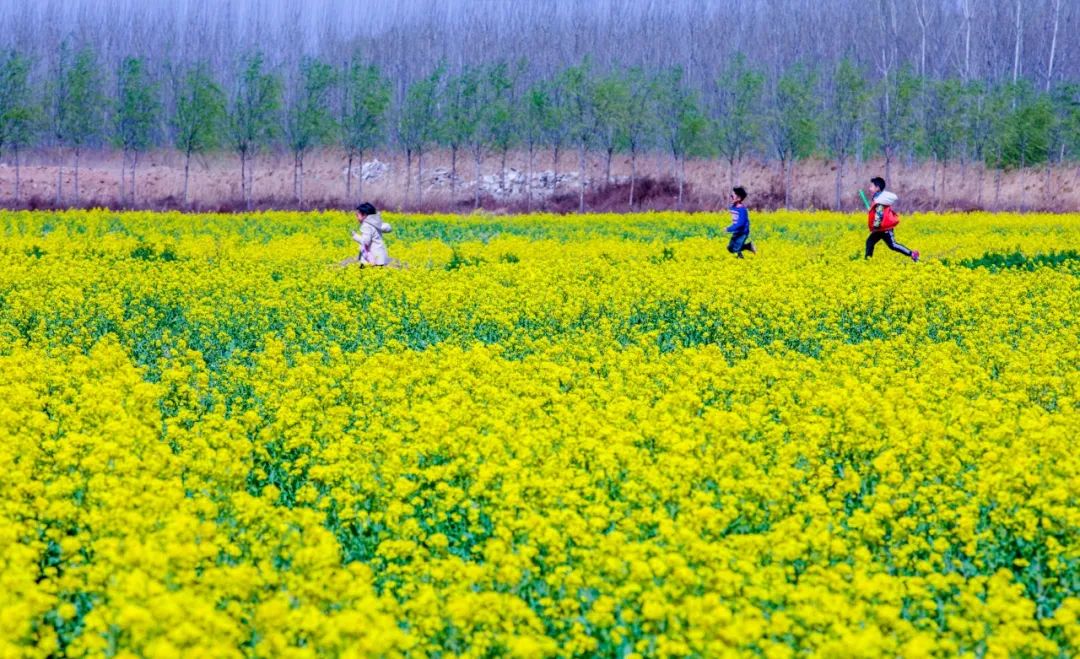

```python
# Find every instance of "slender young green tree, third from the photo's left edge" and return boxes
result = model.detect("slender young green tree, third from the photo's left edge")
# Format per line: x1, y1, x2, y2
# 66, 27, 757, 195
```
113, 57, 161, 205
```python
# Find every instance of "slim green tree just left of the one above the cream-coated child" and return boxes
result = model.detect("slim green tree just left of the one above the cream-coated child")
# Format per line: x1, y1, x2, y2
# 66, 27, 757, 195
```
285, 57, 338, 205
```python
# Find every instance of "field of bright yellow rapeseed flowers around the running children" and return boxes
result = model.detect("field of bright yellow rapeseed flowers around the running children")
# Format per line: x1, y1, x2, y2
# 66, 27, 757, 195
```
0, 211, 1080, 657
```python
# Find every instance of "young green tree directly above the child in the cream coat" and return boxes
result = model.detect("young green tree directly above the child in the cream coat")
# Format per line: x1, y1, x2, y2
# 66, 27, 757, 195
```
340, 56, 390, 199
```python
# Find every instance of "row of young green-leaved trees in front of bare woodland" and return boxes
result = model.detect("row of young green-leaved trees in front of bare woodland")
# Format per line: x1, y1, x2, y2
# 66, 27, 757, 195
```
0, 45, 1080, 206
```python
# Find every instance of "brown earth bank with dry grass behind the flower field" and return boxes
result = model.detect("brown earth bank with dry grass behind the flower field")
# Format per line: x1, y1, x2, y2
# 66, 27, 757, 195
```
0, 151, 1080, 213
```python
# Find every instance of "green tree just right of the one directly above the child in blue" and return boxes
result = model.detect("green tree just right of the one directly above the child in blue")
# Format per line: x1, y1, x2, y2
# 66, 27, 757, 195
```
766, 64, 820, 209
